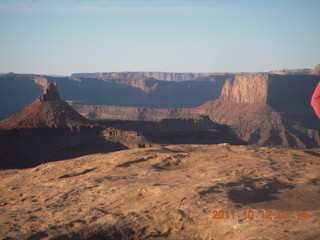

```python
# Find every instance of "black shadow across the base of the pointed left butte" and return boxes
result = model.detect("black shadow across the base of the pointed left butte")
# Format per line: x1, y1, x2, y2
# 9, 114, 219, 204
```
0, 127, 128, 169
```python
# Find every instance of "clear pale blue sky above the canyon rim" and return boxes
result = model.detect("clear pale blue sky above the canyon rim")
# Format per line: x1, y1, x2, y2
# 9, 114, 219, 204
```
0, 0, 320, 75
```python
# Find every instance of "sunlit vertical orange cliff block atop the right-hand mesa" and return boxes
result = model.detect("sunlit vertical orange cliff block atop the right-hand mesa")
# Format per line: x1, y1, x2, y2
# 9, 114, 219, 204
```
220, 73, 268, 104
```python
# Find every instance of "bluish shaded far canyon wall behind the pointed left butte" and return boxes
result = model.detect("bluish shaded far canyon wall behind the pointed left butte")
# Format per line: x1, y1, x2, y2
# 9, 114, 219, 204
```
0, 74, 229, 120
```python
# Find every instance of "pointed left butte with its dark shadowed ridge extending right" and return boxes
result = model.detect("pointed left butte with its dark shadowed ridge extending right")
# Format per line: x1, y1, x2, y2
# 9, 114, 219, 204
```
0, 83, 246, 169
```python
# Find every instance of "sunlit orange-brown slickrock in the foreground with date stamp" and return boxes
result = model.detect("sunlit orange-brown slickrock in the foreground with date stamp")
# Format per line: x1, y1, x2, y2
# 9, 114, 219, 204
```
0, 144, 320, 240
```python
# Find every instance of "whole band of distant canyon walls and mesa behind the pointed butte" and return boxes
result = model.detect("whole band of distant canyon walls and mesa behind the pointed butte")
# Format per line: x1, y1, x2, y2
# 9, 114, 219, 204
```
0, 65, 320, 148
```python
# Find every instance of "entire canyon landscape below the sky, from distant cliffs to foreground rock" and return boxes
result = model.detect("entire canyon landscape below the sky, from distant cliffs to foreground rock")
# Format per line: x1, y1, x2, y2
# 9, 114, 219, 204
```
0, 66, 320, 240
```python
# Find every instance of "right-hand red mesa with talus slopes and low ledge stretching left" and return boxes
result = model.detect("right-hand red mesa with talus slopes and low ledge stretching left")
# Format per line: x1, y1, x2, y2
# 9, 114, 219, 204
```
74, 74, 320, 148
